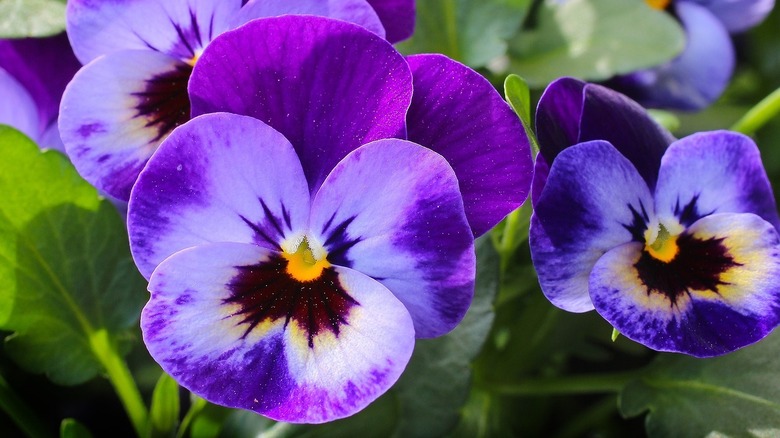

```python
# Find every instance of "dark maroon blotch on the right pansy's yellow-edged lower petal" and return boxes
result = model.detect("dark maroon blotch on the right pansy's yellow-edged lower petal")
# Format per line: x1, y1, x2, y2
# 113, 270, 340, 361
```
634, 233, 740, 307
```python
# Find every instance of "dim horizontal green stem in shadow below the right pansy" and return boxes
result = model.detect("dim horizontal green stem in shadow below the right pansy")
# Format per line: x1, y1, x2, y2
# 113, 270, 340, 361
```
495, 369, 644, 396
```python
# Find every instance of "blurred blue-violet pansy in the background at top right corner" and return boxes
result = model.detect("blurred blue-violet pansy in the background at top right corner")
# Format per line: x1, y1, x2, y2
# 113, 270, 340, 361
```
608, 0, 774, 110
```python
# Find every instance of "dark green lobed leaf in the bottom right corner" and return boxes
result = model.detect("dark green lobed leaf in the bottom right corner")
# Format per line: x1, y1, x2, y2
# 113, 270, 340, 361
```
620, 332, 780, 437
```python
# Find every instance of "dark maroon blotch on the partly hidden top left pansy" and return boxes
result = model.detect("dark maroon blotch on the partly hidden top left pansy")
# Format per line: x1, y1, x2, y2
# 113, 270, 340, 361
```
133, 62, 192, 142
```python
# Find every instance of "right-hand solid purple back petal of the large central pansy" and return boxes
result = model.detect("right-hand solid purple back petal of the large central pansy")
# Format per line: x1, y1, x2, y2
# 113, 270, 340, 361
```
407, 55, 533, 236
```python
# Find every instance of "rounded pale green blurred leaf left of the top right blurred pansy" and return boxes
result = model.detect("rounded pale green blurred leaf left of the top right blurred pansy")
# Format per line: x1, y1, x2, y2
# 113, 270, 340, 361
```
509, 0, 685, 87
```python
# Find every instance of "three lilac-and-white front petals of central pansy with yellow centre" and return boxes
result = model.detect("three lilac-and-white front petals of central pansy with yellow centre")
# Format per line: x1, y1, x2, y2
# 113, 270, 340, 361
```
128, 113, 476, 423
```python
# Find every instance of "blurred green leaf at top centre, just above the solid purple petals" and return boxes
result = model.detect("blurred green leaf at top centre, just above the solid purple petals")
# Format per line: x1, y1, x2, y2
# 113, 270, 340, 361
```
398, 0, 531, 67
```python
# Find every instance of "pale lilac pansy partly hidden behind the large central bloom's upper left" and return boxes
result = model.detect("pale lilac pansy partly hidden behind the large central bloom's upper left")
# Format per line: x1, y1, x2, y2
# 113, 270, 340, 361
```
60, 0, 414, 200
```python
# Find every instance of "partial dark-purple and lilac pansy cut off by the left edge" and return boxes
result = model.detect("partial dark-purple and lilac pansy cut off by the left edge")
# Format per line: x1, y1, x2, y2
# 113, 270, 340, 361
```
0, 33, 81, 151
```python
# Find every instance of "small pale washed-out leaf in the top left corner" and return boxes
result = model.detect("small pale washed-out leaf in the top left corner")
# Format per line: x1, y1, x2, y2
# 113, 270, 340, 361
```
0, 0, 65, 38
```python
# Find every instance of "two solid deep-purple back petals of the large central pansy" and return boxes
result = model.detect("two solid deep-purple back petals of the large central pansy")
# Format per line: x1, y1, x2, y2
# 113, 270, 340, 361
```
189, 16, 532, 236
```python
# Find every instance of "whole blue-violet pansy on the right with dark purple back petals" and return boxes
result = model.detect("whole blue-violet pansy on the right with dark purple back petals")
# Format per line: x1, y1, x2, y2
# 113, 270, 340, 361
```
529, 79, 780, 357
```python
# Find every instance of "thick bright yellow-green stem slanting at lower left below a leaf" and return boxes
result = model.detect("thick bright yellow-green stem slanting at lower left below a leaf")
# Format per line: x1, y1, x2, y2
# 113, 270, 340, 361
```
90, 330, 149, 437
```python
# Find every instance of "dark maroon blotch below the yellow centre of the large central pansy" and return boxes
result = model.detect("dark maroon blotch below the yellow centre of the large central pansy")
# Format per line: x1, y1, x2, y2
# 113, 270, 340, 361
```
224, 255, 359, 348
